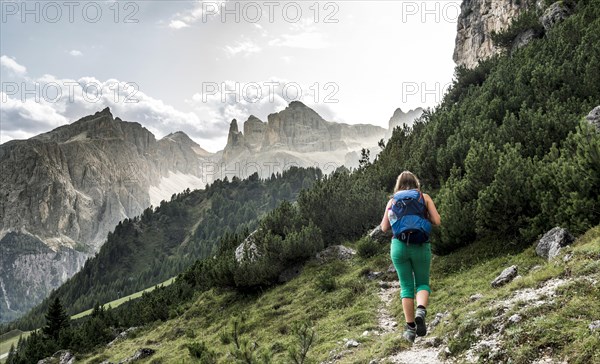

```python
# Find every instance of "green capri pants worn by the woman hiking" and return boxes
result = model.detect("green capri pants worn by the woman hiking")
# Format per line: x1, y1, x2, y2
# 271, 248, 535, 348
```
390, 238, 431, 298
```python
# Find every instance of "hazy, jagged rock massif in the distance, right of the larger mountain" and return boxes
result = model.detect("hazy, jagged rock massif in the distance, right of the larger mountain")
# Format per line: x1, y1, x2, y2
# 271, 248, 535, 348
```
223, 101, 386, 177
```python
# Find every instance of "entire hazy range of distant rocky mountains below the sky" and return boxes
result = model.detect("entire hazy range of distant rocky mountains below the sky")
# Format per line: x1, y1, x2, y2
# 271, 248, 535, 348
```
0, 102, 420, 321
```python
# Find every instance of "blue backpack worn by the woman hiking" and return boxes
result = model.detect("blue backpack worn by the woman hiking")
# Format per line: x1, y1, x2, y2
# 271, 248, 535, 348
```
388, 190, 431, 244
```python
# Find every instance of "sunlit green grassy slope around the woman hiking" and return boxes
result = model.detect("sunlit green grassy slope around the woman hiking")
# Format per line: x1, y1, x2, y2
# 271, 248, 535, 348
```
79, 227, 600, 363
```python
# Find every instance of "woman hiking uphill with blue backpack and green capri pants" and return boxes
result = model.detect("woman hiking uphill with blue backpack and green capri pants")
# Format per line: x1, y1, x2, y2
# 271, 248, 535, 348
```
381, 171, 441, 342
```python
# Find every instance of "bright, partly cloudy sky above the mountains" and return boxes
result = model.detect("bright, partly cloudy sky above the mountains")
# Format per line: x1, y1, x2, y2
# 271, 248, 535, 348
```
0, 0, 460, 152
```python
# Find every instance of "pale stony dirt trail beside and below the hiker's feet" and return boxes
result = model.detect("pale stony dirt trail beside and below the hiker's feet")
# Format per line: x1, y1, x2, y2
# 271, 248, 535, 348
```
377, 282, 444, 364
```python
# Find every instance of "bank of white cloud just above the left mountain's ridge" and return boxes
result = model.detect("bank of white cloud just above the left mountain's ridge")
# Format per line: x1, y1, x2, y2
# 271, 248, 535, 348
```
0, 63, 227, 151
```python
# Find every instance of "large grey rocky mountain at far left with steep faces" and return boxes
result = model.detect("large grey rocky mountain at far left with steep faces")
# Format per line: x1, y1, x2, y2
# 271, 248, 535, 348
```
0, 109, 212, 316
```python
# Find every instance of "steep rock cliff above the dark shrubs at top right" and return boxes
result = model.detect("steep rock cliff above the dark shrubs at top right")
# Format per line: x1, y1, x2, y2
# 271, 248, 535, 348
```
453, 0, 534, 68
